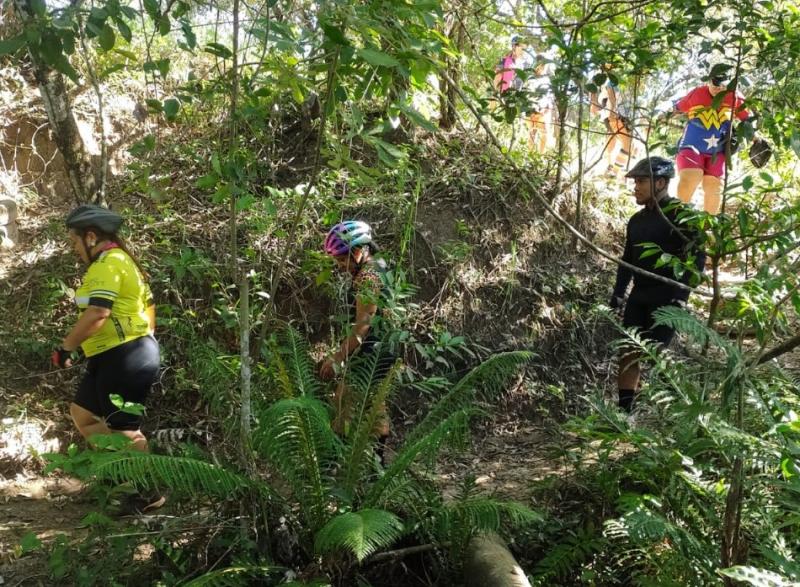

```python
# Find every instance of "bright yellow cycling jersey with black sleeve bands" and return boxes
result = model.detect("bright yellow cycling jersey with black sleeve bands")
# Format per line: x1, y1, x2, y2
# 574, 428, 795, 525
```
75, 247, 153, 357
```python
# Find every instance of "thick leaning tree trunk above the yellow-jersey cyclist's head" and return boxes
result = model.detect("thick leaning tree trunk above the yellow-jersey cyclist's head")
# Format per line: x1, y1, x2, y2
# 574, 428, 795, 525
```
15, 0, 100, 203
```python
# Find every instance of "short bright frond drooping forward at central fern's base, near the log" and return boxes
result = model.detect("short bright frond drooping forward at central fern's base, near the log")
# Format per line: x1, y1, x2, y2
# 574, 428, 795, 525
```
314, 509, 403, 562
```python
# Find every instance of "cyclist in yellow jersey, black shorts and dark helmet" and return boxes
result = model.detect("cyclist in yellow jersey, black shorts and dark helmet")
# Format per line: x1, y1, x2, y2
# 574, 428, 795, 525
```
52, 205, 164, 511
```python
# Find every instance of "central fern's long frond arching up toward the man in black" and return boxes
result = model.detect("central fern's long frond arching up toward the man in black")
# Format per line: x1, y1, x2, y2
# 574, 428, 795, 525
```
408, 351, 533, 443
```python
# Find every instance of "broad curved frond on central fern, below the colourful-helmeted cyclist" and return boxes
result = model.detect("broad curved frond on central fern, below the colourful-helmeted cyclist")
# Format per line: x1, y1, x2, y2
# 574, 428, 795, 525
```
256, 396, 337, 531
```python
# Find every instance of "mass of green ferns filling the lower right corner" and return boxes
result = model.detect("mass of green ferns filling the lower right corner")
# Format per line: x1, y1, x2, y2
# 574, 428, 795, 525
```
537, 307, 800, 586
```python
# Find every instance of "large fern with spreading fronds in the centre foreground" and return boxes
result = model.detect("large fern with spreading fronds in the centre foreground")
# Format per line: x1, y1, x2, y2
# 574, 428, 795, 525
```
50, 328, 538, 583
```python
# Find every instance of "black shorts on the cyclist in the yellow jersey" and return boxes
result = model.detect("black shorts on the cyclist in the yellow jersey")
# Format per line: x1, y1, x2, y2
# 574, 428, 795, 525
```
74, 336, 160, 430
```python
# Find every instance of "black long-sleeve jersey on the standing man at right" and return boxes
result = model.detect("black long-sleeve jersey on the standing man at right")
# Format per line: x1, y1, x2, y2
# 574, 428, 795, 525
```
614, 197, 706, 304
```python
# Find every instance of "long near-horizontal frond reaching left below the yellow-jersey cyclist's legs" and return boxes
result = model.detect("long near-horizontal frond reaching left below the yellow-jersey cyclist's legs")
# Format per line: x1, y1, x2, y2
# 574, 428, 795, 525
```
93, 451, 264, 497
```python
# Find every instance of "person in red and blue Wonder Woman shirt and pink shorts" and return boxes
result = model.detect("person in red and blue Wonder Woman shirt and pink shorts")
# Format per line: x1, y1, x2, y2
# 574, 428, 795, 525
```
675, 70, 750, 214
